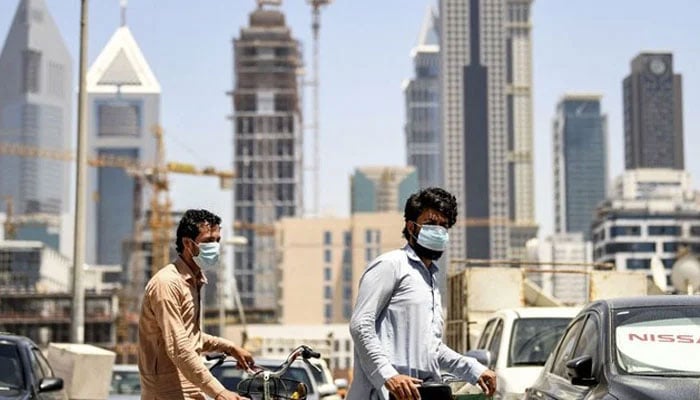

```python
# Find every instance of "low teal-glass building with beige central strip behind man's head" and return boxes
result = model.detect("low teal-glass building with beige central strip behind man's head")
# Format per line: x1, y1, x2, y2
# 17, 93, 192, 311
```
350, 167, 418, 214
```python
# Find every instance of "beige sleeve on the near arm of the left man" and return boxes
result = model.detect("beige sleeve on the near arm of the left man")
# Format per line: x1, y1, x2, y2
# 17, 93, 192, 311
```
152, 282, 225, 398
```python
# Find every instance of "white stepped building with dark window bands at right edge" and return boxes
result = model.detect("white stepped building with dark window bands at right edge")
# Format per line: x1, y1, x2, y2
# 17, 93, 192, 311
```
592, 169, 700, 282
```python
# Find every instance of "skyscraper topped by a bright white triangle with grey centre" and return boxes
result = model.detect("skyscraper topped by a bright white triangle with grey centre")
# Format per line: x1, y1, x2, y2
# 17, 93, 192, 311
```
86, 21, 160, 264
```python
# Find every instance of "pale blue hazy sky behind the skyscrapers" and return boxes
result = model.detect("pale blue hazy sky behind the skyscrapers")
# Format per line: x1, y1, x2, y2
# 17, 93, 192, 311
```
0, 0, 700, 241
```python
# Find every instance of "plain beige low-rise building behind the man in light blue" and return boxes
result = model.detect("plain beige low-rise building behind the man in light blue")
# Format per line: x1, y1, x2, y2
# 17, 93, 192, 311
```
275, 211, 405, 324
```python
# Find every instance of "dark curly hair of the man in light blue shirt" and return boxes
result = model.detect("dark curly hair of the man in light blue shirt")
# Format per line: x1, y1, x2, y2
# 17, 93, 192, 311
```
403, 187, 457, 240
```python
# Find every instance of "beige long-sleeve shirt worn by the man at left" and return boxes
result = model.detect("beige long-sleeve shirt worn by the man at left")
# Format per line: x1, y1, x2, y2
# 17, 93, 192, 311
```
138, 258, 234, 400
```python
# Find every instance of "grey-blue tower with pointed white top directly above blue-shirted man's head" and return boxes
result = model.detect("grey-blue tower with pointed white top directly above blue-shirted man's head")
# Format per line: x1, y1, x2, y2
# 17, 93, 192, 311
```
404, 7, 443, 188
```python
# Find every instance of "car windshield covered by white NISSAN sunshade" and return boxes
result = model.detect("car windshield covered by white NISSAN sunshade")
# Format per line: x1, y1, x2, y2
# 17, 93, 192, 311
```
613, 306, 700, 376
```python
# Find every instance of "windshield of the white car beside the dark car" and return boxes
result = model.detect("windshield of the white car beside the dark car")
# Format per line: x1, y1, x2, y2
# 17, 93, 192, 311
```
508, 318, 571, 367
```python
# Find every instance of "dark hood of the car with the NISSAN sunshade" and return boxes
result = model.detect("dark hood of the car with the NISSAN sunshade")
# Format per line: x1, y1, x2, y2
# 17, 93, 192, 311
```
609, 375, 700, 400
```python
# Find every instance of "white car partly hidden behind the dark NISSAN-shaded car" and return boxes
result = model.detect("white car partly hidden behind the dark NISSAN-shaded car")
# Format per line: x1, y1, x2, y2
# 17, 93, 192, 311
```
467, 307, 581, 400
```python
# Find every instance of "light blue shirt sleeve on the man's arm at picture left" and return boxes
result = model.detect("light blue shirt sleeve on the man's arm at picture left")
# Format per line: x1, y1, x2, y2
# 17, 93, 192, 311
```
350, 260, 398, 389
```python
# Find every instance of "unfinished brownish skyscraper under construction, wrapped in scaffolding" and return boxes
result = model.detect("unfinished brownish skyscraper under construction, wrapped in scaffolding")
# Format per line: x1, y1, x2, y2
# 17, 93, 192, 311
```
232, 0, 303, 310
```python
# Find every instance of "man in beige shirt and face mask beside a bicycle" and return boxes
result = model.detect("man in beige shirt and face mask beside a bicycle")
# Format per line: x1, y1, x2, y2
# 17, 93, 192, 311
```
138, 210, 253, 400
